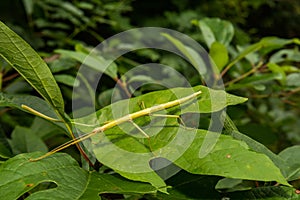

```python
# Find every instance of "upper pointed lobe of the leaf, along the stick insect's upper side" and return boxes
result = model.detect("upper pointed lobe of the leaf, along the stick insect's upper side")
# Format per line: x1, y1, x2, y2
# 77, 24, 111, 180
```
86, 86, 247, 123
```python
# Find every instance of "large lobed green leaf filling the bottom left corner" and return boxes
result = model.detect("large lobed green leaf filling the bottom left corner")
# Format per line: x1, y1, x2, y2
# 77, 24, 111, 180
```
0, 153, 156, 200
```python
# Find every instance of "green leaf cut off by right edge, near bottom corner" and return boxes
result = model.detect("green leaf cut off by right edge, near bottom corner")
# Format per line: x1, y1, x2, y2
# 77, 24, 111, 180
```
278, 145, 300, 181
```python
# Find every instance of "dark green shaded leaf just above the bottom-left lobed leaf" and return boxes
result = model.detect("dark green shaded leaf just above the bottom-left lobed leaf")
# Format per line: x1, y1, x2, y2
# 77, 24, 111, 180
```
9, 126, 48, 155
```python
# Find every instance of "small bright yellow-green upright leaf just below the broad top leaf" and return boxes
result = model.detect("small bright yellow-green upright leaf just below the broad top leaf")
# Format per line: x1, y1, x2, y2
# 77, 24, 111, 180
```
209, 42, 229, 71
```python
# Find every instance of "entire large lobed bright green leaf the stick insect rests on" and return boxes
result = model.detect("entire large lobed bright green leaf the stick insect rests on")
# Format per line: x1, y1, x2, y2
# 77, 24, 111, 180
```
72, 86, 288, 191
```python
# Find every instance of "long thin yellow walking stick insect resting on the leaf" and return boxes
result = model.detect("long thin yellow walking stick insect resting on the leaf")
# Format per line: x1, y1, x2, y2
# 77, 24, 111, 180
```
28, 91, 201, 161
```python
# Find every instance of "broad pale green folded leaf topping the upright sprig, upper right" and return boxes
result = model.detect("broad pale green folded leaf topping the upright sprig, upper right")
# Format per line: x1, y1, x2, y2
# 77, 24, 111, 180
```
198, 18, 234, 48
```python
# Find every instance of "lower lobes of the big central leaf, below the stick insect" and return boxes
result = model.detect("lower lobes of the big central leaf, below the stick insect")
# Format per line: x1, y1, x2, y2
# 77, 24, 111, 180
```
87, 126, 288, 188
